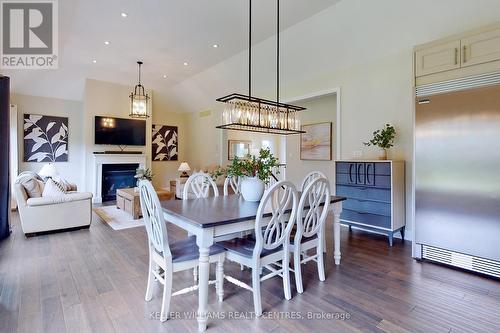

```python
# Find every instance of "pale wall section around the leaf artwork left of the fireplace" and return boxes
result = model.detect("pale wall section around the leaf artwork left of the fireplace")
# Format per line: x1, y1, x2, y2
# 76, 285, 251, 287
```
10, 94, 84, 189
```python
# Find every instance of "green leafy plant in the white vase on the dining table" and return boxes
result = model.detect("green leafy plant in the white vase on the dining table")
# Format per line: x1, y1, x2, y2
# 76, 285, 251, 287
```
210, 149, 279, 184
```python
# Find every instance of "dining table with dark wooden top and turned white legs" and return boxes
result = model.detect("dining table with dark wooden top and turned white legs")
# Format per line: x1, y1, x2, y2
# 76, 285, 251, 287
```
161, 194, 346, 332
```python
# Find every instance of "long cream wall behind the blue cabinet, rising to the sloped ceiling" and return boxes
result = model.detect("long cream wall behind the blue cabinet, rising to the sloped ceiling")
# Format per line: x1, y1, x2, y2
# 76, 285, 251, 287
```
173, 0, 500, 239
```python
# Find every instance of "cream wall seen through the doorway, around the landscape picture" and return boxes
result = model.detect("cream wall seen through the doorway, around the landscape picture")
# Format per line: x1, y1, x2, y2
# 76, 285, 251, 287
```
286, 95, 337, 190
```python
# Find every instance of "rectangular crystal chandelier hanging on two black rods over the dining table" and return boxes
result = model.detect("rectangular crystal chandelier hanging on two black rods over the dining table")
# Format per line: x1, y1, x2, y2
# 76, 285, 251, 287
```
216, 0, 306, 135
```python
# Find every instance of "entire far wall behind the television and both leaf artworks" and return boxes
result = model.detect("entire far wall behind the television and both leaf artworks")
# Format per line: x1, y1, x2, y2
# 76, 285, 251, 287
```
11, 79, 189, 191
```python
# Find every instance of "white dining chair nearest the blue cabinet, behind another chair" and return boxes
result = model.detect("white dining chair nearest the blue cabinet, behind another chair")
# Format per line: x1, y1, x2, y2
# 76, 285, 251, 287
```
290, 177, 330, 293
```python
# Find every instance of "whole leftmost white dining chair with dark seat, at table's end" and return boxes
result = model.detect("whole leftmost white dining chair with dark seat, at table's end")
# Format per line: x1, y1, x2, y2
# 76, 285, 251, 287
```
139, 180, 225, 322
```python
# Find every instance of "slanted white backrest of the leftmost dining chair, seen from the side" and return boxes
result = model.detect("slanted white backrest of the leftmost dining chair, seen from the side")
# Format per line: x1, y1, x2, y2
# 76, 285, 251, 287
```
139, 180, 172, 260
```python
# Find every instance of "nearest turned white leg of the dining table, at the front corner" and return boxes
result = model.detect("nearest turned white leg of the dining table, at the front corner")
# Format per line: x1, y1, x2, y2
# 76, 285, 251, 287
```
196, 230, 213, 332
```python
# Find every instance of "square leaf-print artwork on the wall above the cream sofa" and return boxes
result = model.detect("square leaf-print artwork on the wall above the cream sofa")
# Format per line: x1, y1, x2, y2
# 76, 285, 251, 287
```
23, 114, 68, 162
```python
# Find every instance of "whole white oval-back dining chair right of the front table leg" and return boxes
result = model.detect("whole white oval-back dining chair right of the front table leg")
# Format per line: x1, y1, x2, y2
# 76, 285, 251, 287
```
219, 181, 298, 316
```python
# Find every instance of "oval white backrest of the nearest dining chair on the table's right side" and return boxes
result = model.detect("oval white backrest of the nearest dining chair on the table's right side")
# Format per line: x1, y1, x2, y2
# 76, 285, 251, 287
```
253, 181, 298, 258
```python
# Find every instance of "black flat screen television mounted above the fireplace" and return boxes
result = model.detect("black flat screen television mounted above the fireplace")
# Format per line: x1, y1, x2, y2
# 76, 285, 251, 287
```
94, 116, 146, 146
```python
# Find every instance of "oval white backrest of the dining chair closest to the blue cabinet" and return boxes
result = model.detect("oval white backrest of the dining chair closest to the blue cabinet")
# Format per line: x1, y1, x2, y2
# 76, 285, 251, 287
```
294, 178, 330, 246
